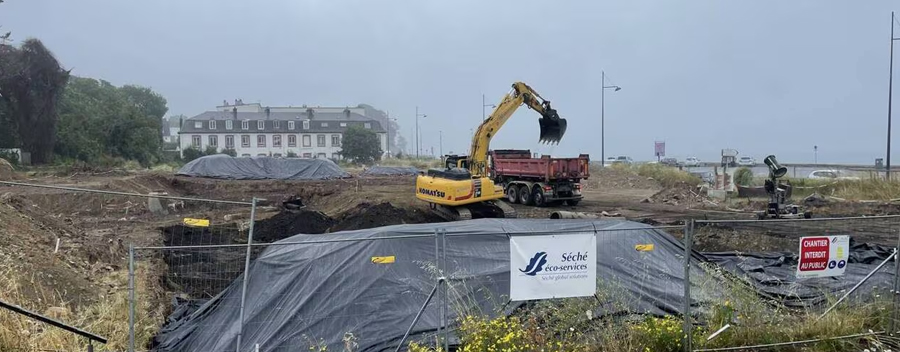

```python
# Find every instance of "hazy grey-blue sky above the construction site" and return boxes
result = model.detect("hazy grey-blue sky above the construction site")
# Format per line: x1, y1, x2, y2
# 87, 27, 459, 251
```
0, 0, 900, 164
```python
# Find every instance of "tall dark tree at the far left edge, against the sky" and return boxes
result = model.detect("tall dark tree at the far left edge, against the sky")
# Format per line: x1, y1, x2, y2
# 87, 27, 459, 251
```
0, 39, 69, 164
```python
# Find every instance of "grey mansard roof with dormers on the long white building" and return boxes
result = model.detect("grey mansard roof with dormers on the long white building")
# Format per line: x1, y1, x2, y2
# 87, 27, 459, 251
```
180, 111, 385, 134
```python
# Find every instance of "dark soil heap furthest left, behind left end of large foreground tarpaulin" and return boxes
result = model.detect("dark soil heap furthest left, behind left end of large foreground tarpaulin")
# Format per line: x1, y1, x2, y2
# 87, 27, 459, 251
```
253, 210, 334, 239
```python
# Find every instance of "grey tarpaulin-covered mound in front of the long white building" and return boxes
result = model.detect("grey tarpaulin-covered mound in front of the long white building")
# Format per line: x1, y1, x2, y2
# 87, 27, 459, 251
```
176, 154, 350, 180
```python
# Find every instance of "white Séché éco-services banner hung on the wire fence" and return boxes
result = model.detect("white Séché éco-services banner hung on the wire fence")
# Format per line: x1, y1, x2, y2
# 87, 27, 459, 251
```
509, 233, 597, 301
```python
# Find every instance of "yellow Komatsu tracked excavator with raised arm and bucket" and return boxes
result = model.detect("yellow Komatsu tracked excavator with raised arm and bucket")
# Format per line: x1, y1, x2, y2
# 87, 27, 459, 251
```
416, 82, 566, 221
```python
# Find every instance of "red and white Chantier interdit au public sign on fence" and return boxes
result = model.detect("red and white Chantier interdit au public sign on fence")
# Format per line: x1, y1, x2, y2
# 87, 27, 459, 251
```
797, 236, 850, 279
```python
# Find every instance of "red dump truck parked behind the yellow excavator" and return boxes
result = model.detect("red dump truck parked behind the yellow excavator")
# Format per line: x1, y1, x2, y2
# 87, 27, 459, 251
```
489, 149, 590, 206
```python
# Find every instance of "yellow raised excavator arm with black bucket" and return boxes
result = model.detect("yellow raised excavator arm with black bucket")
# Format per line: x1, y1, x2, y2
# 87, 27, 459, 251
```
468, 82, 566, 177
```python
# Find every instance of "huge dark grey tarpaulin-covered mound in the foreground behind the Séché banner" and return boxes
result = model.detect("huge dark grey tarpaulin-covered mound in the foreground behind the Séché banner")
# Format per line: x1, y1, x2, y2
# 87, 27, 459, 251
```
153, 219, 706, 351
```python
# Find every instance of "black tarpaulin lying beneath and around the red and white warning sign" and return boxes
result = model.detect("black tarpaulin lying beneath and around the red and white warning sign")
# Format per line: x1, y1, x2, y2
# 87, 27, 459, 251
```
703, 241, 894, 308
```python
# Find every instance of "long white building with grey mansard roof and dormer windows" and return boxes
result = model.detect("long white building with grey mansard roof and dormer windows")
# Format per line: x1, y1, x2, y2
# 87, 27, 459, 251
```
179, 102, 387, 159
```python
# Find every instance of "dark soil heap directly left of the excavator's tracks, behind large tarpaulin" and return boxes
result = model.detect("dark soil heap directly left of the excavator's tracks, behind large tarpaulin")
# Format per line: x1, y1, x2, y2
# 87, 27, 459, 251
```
331, 202, 442, 232
